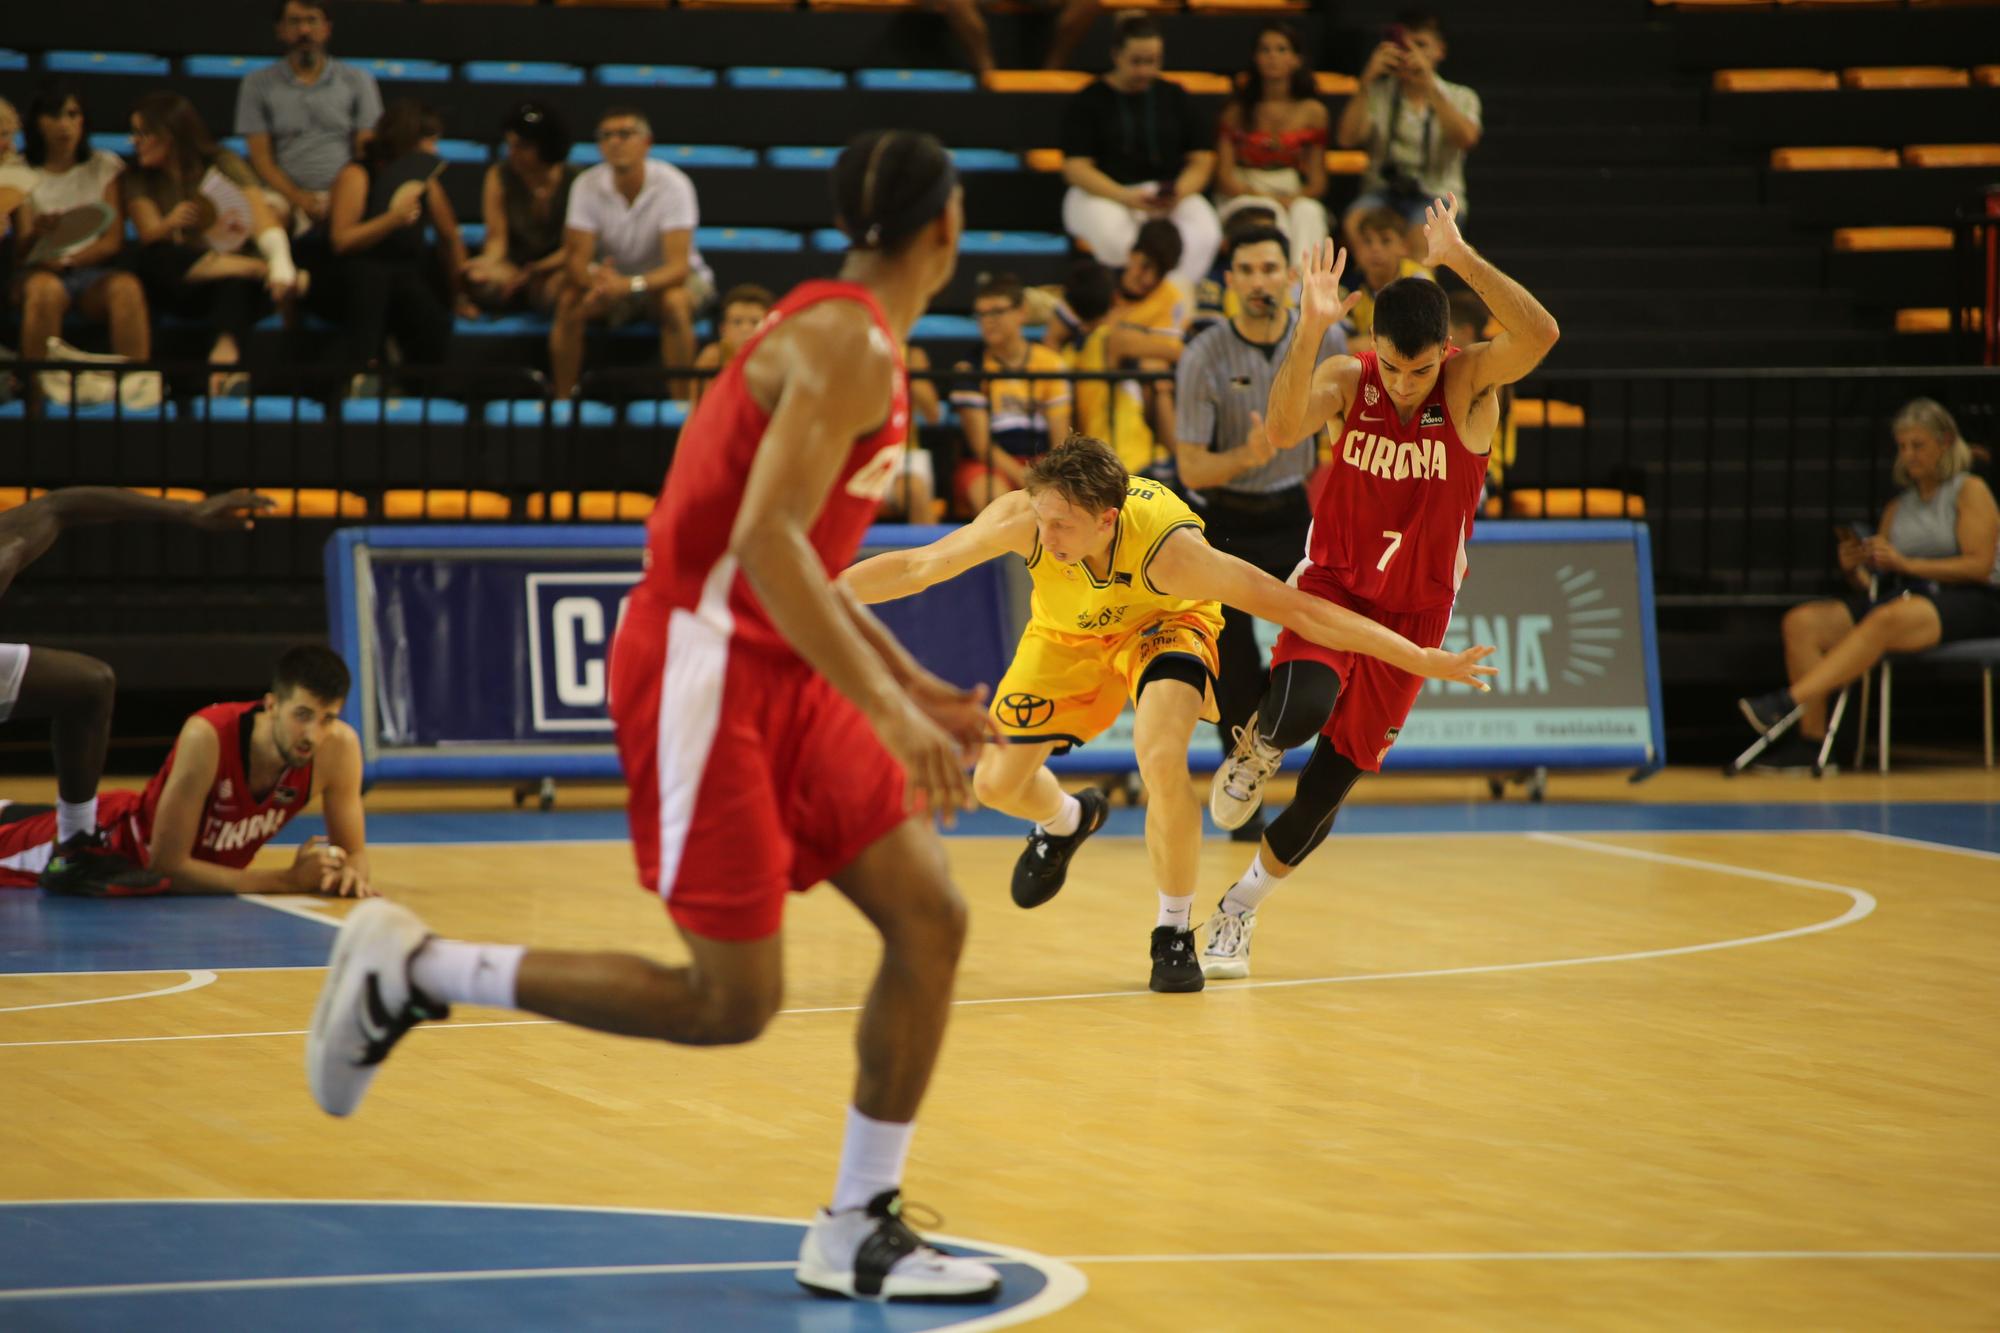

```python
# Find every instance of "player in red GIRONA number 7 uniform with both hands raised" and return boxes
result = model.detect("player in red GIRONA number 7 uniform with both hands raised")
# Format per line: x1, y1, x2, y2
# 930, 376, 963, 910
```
1202, 189, 1560, 977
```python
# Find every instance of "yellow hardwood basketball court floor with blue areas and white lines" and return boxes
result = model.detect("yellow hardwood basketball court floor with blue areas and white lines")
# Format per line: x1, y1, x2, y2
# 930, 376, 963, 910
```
0, 769, 2000, 1329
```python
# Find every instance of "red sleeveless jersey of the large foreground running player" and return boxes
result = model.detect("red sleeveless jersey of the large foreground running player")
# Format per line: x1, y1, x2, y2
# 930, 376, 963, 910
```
632, 280, 910, 652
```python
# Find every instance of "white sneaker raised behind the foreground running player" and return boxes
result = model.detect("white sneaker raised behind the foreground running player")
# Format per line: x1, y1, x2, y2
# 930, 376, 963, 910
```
306, 899, 452, 1115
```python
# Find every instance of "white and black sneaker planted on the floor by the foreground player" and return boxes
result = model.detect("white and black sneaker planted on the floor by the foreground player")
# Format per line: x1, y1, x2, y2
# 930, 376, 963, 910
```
796, 1189, 1000, 1301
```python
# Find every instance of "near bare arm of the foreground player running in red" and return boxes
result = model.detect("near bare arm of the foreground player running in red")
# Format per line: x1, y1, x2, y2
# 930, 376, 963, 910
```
730, 300, 972, 813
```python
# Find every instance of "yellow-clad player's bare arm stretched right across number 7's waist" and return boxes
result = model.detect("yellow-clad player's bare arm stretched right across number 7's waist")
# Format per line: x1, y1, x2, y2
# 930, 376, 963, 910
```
1146, 528, 1496, 691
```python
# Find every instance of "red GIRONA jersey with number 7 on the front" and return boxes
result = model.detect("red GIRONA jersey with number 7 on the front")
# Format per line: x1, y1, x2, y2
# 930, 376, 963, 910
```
1308, 348, 1486, 610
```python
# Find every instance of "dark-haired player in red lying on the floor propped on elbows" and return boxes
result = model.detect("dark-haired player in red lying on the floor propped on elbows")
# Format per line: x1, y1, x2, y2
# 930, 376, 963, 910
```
0, 646, 374, 897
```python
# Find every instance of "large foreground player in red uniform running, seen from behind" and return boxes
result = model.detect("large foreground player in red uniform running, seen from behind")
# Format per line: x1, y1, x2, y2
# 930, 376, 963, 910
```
306, 130, 1016, 1301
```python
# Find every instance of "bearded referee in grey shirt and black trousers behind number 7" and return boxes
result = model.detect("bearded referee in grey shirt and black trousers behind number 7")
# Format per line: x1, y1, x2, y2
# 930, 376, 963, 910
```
1174, 226, 1348, 841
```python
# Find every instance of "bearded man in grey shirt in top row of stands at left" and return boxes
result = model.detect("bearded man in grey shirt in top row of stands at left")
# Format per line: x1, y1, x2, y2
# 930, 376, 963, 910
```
236, 0, 382, 232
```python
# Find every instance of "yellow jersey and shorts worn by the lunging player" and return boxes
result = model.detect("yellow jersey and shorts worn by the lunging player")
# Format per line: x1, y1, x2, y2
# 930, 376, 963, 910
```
992, 476, 1222, 753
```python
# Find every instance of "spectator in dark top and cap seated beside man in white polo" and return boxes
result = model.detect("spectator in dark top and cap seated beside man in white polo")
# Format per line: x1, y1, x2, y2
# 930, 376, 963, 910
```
466, 102, 576, 312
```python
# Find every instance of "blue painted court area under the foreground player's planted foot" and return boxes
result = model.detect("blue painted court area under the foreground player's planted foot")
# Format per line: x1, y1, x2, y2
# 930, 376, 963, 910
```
0, 1201, 1080, 1333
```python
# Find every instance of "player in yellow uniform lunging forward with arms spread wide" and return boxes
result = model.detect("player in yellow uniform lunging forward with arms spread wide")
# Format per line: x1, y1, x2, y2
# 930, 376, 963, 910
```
842, 434, 1494, 991
